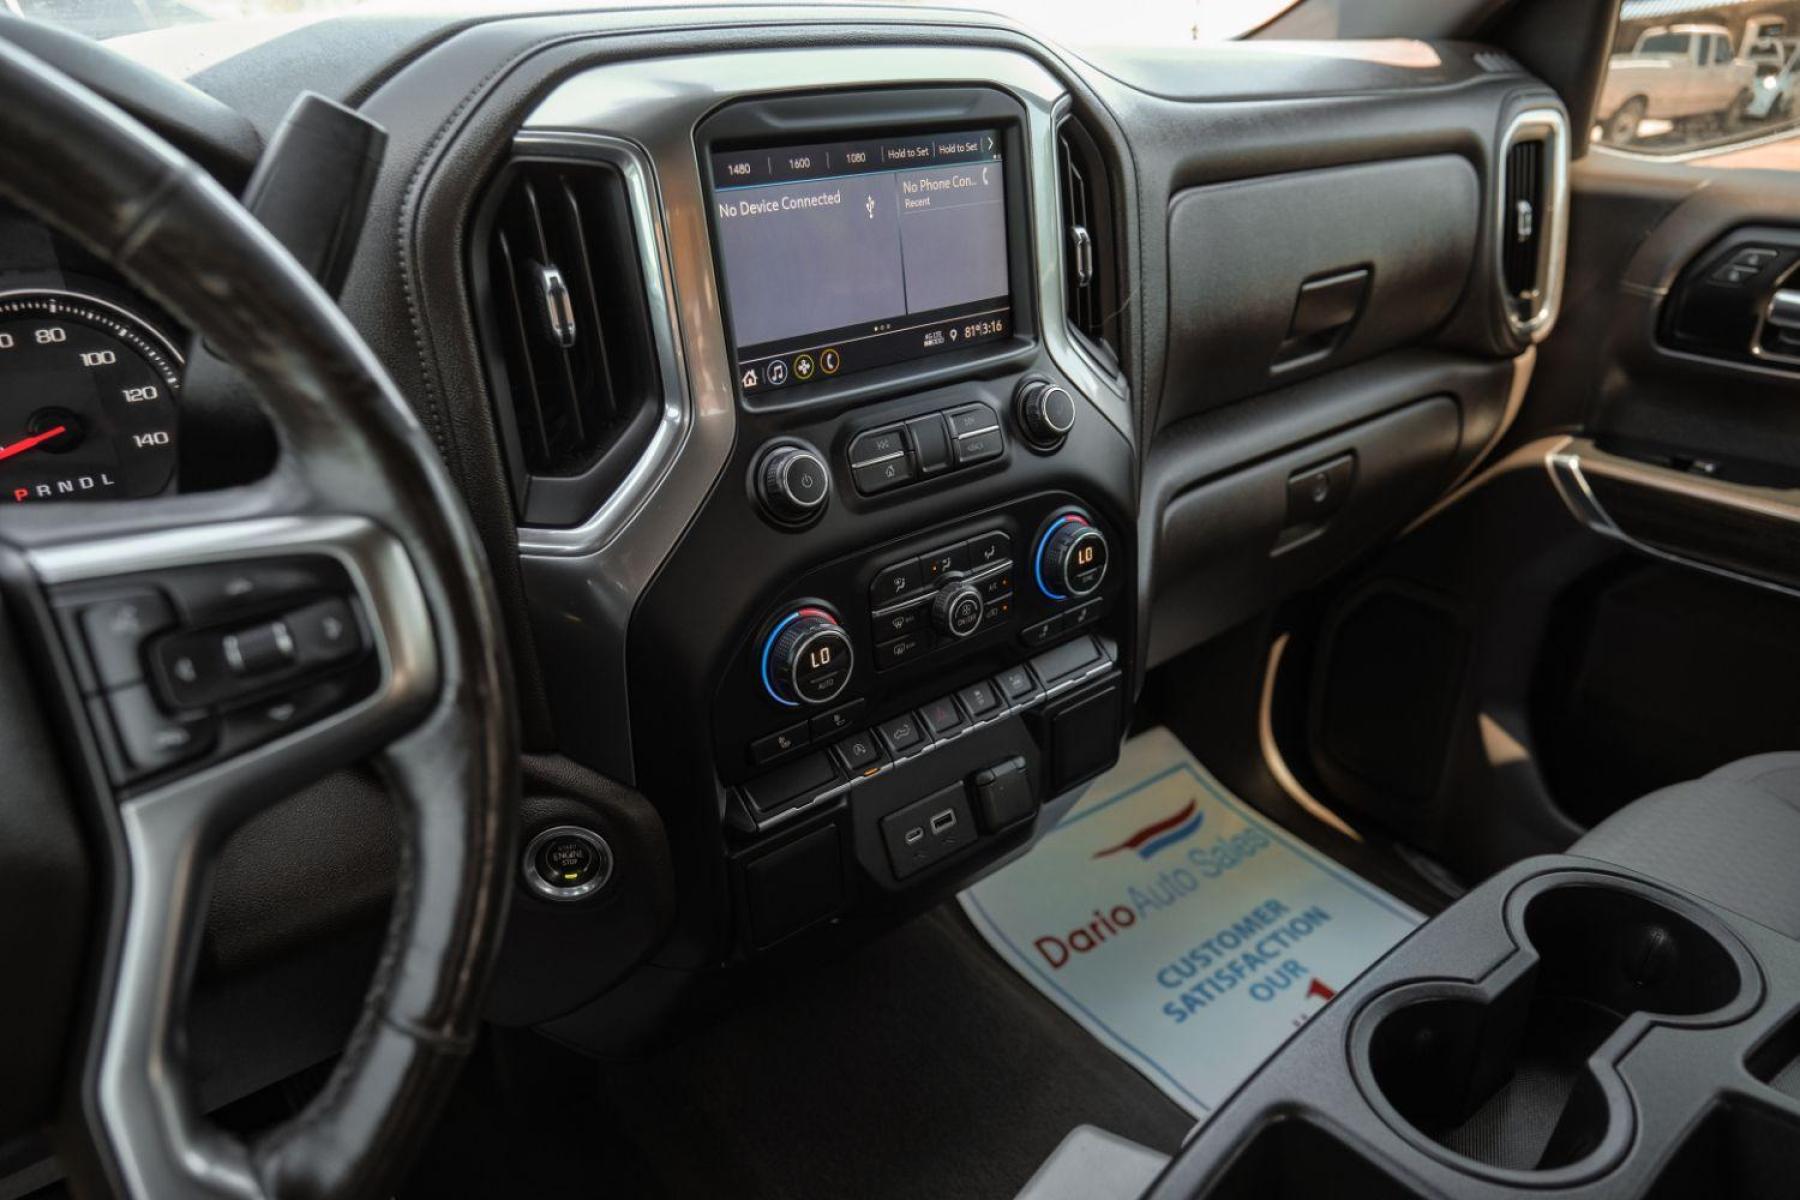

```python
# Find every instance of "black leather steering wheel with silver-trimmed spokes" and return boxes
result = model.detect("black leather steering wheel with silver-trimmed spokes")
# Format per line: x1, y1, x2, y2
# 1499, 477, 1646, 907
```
0, 32, 518, 1200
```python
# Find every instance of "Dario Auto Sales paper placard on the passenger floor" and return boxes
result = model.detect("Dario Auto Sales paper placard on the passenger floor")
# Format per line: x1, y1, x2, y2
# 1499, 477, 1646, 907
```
961, 729, 1422, 1117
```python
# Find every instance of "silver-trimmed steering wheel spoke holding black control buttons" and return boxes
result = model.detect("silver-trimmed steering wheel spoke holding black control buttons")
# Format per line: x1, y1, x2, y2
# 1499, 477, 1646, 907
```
15, 506, 441, 1196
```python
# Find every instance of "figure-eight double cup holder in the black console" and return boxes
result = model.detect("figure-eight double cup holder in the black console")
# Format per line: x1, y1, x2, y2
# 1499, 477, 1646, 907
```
1352, 874, 1760, 1186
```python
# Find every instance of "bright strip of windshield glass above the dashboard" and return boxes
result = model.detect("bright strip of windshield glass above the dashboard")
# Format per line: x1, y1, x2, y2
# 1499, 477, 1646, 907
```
0, 0, 1296, 47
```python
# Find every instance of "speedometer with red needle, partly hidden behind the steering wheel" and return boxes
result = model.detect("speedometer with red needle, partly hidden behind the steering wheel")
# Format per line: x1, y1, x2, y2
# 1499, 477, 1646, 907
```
0, 291, 182, 504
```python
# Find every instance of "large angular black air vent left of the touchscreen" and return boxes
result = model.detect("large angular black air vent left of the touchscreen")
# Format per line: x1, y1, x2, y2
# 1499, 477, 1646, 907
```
473, 158, 659, 525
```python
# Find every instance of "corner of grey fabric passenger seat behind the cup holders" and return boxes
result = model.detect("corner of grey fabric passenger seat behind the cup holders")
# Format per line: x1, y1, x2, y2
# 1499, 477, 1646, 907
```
1570, 752, 1800, 937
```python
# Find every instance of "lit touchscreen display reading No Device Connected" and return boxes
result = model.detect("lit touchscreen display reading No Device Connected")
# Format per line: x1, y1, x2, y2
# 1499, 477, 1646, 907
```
713, 130, 1012, 394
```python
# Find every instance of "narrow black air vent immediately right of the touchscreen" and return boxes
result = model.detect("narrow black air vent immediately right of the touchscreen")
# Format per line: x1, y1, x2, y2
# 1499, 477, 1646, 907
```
1057, 119, 1120, 374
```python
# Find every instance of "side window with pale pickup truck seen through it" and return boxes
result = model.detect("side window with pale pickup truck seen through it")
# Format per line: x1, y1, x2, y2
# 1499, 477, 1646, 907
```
1593, 0, 1800, 167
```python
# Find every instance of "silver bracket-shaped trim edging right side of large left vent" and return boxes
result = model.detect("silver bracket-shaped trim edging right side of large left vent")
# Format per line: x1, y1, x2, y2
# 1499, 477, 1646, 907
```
513, 131, 702, 556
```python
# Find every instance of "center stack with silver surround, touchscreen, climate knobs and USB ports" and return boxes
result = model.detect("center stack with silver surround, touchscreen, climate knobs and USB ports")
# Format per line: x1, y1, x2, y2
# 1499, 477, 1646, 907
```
500, 67, 1141, 985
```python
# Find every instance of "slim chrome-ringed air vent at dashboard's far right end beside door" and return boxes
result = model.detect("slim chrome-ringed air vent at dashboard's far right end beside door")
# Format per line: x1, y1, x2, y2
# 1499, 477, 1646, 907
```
1498, 110, 1568, 342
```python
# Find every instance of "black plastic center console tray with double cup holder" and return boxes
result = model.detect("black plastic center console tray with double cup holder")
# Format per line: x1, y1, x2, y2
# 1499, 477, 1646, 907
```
1150, 856, 1800, 1200
